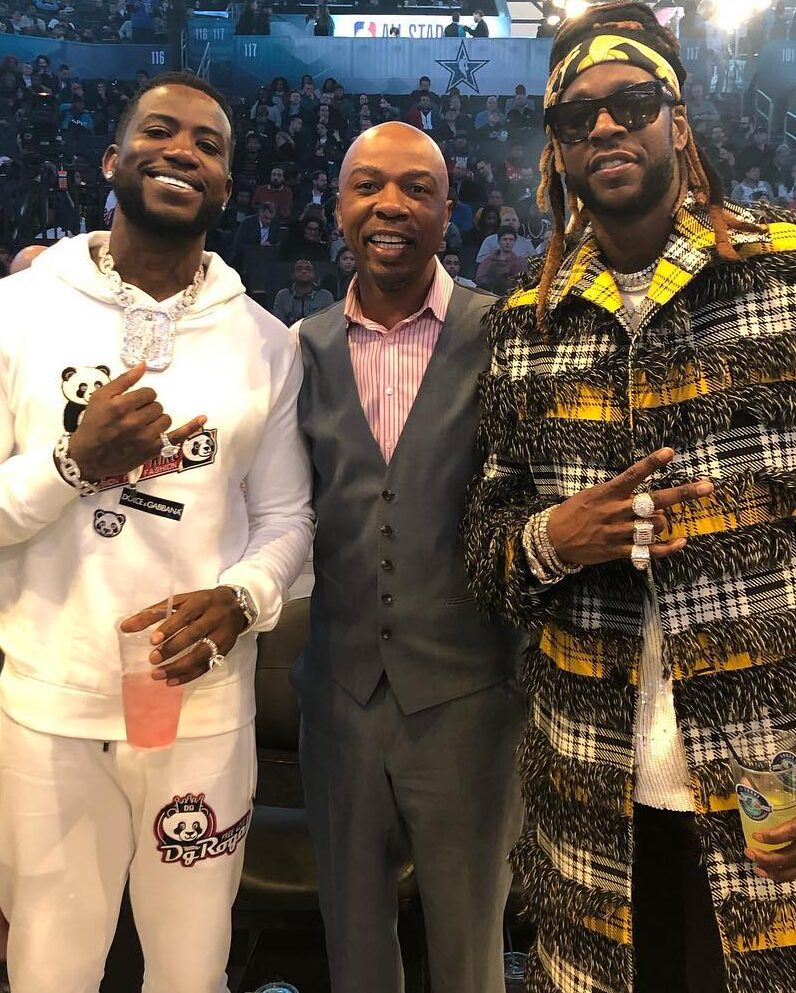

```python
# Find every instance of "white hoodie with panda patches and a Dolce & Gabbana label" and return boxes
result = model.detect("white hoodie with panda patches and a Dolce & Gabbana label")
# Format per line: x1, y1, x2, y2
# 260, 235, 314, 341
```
0, 233, 312, 740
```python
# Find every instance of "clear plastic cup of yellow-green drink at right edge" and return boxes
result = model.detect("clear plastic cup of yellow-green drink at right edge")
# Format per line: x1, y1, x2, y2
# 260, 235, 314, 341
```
730, 728, 796, 852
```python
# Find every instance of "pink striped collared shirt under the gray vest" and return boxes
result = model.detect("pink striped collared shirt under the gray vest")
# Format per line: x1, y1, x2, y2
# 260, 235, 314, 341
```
344, 260, 453, 462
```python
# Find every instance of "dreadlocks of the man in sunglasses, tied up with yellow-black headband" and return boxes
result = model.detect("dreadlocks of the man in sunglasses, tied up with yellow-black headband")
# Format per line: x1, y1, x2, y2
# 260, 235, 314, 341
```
536, 0, 762, 325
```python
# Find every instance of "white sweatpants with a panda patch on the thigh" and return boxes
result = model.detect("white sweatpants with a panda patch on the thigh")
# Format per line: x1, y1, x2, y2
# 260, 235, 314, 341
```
0, 712, 257, 993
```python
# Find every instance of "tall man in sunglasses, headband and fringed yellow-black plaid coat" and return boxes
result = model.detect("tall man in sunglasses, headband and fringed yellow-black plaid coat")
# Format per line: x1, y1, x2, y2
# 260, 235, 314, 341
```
464, 3, 796, 993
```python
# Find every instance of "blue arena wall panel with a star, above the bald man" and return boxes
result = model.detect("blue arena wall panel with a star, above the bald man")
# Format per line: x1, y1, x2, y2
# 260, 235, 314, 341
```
211, 36, 552, 95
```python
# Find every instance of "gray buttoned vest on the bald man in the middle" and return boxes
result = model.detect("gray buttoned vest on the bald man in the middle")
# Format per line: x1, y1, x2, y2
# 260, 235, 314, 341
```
294, 286, 522, 713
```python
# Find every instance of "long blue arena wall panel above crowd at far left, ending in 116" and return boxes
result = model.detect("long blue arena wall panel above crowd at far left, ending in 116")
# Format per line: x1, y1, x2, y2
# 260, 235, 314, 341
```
0, 34, 174, 79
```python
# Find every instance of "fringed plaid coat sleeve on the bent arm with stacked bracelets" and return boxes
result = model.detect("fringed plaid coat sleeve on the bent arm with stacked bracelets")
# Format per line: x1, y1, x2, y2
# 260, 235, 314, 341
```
463, 336, 566, 630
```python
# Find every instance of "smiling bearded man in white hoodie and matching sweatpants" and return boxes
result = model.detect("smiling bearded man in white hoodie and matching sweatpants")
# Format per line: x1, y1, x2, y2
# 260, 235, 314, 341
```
0, 74, 312, 993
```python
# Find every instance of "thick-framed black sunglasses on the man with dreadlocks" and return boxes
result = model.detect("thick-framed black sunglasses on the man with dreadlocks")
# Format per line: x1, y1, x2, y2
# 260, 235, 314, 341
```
544, 80, 680, 145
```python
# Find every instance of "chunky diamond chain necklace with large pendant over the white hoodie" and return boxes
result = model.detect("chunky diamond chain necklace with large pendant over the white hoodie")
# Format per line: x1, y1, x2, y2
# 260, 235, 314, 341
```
97, 245, 205, 372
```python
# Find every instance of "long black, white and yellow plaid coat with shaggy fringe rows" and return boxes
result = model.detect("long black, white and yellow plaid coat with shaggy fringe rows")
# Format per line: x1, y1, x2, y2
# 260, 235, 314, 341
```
464, 200, 796, 993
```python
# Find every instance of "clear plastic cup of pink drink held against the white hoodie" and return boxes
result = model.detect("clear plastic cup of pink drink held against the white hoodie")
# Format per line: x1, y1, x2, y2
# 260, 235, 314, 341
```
116, 626, 182, 748
